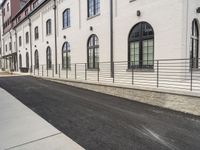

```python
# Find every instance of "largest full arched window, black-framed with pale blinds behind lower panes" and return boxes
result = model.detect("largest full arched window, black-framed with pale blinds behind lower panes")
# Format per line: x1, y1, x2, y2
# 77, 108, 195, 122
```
128, 22, 154, 69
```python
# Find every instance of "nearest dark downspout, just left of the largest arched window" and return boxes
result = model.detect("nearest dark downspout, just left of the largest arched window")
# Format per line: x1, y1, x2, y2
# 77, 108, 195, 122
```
110, 0, 114, 78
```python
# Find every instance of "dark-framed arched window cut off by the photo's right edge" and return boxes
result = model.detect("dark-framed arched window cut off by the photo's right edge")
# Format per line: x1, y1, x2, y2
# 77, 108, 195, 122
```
191, 19, 199, 68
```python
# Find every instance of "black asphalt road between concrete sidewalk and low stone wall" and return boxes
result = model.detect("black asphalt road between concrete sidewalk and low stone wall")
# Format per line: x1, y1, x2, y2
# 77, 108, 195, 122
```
0, 77, 200, 150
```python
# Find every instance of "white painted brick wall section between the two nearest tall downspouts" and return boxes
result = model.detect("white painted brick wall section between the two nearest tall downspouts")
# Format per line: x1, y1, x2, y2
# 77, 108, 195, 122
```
58, 0, 110, 63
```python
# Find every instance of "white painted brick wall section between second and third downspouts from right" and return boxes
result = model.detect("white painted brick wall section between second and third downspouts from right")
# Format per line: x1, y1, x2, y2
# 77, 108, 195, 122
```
31, 1, 55, 65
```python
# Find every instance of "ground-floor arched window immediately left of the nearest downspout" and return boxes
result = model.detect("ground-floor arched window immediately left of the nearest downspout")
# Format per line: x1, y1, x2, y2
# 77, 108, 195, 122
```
87, 34, 99, 69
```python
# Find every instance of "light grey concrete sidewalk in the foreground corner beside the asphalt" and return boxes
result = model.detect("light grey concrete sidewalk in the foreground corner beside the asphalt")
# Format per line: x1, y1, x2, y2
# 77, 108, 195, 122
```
0, 88, 83, 150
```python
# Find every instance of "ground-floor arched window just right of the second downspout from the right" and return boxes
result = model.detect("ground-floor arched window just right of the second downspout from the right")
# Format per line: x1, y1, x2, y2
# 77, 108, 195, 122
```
62, 42, 71, 69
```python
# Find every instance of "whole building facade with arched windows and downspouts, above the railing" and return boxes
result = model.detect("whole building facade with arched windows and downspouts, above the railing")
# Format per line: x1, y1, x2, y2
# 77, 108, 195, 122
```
1, 0, 200, 75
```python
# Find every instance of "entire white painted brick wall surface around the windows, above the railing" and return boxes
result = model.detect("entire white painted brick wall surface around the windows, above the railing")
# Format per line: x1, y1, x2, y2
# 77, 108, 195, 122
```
0, 0, 200, 72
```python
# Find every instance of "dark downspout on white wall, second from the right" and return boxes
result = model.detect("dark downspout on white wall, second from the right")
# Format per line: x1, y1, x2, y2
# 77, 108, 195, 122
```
53, 0, 58, 74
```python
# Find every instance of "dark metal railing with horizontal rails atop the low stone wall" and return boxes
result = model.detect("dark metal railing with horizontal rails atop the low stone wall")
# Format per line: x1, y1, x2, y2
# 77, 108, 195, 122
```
33, 59, 200, 92
